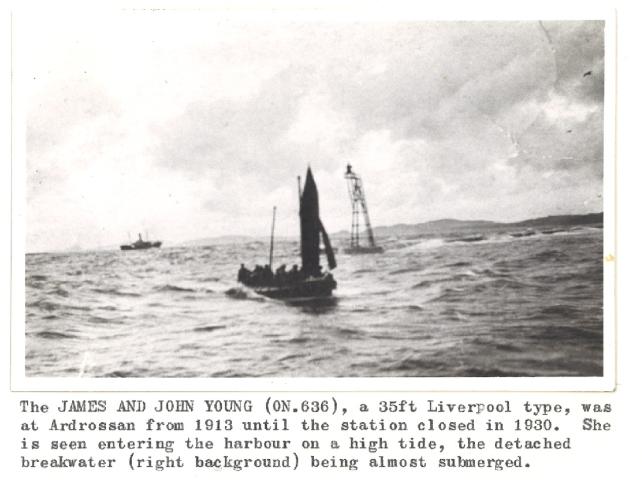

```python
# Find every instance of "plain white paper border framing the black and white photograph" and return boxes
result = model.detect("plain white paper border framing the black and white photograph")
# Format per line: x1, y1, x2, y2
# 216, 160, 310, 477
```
9, 3, 618, 393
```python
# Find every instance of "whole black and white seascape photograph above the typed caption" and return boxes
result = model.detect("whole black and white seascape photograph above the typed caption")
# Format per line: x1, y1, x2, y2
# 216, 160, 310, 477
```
21, 10, 612, 378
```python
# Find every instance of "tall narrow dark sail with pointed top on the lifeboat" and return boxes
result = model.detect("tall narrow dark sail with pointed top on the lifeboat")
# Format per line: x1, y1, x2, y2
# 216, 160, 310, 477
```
299, 167, 321, 276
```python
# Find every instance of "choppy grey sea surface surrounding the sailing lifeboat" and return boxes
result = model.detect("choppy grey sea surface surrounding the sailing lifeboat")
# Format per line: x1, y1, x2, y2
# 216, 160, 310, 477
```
25, 226, 603, 377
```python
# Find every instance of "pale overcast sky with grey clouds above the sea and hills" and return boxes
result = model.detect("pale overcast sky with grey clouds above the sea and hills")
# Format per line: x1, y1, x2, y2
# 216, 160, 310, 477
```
22, 11, 604, 251
